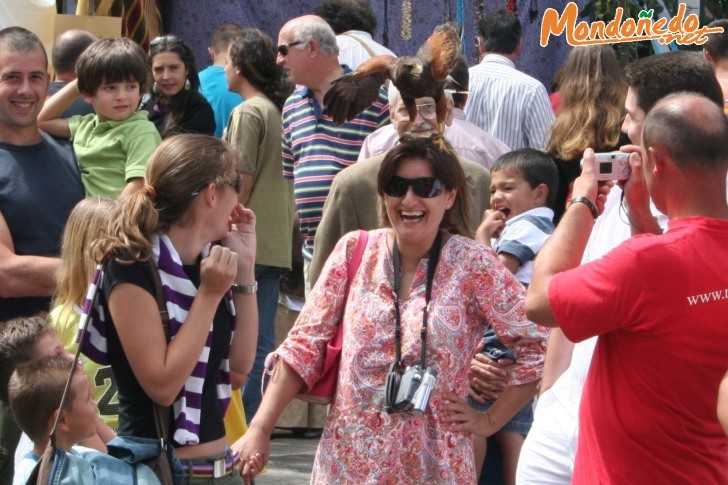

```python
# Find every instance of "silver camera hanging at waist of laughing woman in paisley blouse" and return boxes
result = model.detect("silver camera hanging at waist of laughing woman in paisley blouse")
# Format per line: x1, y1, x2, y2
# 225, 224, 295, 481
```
384, 364, 437, 416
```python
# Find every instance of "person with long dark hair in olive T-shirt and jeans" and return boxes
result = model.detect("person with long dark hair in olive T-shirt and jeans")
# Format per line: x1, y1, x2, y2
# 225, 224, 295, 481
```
223, 28, 294, 420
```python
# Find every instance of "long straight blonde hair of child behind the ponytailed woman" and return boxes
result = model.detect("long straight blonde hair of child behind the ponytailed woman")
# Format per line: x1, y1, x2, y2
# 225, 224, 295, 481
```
53, 197, 118, 322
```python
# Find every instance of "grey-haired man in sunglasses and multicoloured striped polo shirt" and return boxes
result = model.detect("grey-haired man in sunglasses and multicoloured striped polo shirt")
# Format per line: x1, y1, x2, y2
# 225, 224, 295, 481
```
277, 15, 389, 293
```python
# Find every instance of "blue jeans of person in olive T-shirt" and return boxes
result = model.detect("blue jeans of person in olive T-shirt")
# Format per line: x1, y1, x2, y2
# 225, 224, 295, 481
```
243, 264, 281, 423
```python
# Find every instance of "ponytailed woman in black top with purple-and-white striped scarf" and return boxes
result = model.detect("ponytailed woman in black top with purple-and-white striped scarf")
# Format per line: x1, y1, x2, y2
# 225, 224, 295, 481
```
89, 134, 258, 483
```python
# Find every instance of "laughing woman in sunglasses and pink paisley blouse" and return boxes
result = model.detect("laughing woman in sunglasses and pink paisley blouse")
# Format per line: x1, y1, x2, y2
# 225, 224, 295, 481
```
233, 138, 546, 483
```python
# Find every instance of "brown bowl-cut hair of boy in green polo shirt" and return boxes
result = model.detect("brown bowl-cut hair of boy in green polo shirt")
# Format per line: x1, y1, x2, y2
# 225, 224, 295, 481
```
76, 37, 151, 95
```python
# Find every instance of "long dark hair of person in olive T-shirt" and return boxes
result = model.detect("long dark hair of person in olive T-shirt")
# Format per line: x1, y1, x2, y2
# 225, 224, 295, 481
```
230, 29, 293, 110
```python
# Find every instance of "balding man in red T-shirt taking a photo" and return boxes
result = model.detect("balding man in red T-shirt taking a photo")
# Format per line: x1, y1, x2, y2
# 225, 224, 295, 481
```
526, 93, 728, 484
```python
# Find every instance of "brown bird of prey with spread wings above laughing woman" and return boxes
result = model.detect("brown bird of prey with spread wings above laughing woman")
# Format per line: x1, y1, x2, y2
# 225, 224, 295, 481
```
324, 26, 460, 148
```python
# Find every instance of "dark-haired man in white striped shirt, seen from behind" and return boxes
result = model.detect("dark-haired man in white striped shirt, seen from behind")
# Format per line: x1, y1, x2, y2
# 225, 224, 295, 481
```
465, 9, 554, 150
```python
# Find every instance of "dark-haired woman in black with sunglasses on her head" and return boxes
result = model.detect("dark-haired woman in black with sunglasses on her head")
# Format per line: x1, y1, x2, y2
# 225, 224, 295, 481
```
139, 35, 215, 138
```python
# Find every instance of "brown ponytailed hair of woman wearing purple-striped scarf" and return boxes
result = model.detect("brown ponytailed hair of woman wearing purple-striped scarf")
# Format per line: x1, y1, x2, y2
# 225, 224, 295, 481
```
93, 134, 239, 263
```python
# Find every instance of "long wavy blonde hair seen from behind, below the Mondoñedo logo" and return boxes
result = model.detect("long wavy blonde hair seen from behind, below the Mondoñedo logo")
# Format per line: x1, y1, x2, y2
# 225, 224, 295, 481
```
545, 45, 627, 160
